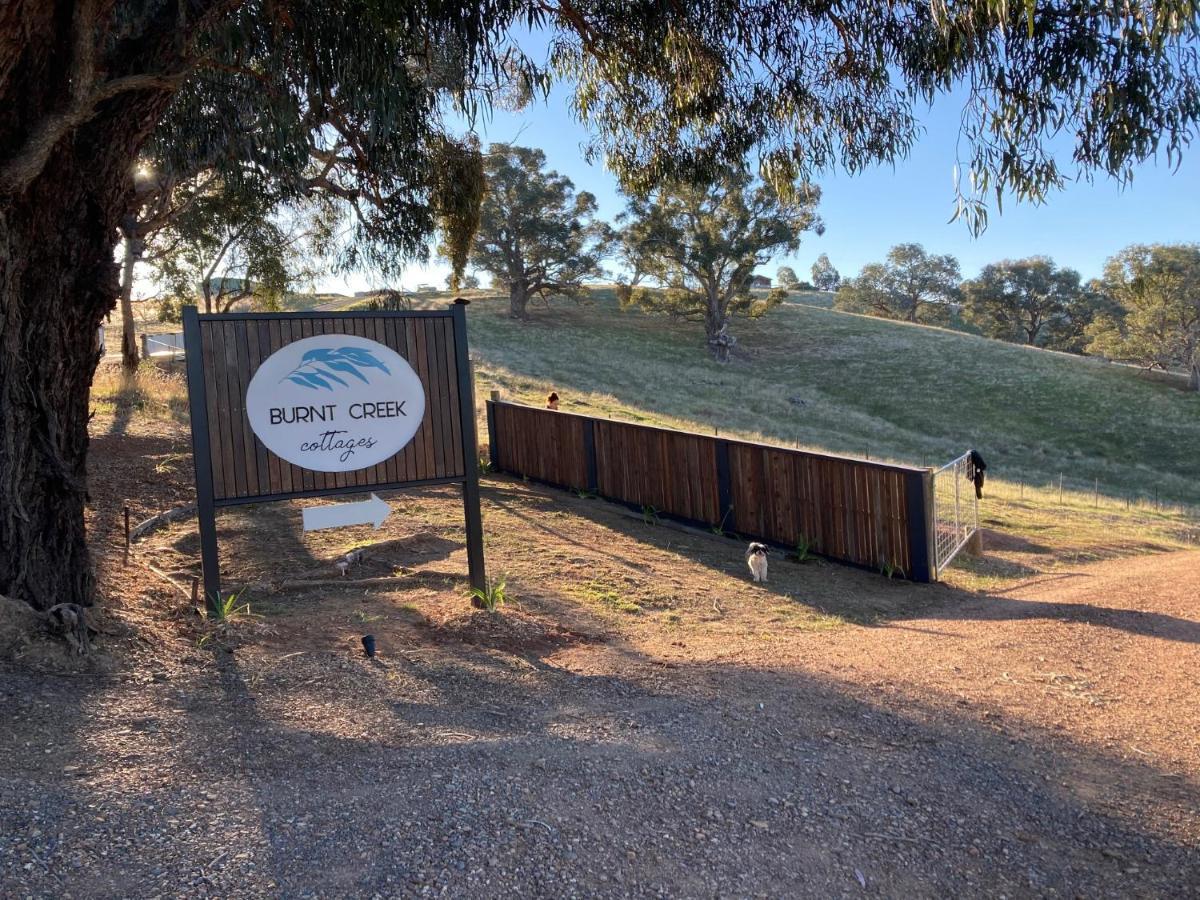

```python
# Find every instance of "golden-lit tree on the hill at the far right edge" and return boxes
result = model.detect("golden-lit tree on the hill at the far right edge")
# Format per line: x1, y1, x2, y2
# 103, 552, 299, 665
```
1087, 244, 1200, 391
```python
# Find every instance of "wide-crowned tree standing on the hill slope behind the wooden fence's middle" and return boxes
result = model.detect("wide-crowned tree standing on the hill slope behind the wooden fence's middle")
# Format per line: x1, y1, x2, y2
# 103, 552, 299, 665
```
622, 172, 823, 362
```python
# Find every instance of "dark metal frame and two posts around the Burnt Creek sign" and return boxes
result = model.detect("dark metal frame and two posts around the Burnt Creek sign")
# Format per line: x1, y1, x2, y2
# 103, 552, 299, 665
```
184, 301, 486, 611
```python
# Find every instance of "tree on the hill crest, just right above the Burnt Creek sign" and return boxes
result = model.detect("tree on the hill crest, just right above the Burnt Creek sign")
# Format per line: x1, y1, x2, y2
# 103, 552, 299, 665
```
470, 144, 611, 319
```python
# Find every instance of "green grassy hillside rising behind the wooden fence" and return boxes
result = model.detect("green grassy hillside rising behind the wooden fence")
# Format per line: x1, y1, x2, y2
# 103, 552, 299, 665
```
433, 288, 1200, 504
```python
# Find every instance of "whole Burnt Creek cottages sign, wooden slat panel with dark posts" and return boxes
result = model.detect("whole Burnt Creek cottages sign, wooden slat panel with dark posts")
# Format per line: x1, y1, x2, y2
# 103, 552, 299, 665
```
184, 304, 484, 609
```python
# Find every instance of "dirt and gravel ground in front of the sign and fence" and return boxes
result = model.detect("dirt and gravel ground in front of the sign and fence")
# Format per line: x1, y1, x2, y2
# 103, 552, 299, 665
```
0, 418, 1200, 898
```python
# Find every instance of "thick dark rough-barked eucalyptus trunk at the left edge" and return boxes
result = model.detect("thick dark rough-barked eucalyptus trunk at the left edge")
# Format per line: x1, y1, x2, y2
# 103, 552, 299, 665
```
0, 22, 177, 610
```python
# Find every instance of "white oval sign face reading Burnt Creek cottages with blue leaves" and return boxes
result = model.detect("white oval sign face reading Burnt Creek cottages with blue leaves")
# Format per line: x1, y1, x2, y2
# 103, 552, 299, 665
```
246, 335, 425, 472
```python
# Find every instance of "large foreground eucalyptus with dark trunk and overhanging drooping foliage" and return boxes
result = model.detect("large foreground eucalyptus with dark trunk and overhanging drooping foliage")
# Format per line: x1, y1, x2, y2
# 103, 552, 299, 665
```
0, 0, 1200, 607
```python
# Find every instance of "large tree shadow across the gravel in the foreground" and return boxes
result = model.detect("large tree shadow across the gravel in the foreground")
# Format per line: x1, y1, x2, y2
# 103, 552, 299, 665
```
0, 628, 1200, 896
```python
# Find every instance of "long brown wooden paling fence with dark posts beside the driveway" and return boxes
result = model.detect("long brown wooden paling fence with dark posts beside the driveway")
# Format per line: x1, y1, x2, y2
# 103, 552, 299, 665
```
487, 396, 935, 581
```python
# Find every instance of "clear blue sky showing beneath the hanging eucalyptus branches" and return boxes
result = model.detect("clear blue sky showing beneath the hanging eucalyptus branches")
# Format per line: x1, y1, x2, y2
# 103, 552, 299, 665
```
323, 80, 1200, 290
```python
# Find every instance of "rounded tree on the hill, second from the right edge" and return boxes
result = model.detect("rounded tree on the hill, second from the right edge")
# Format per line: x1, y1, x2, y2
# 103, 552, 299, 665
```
962, 257, 1098, 350
